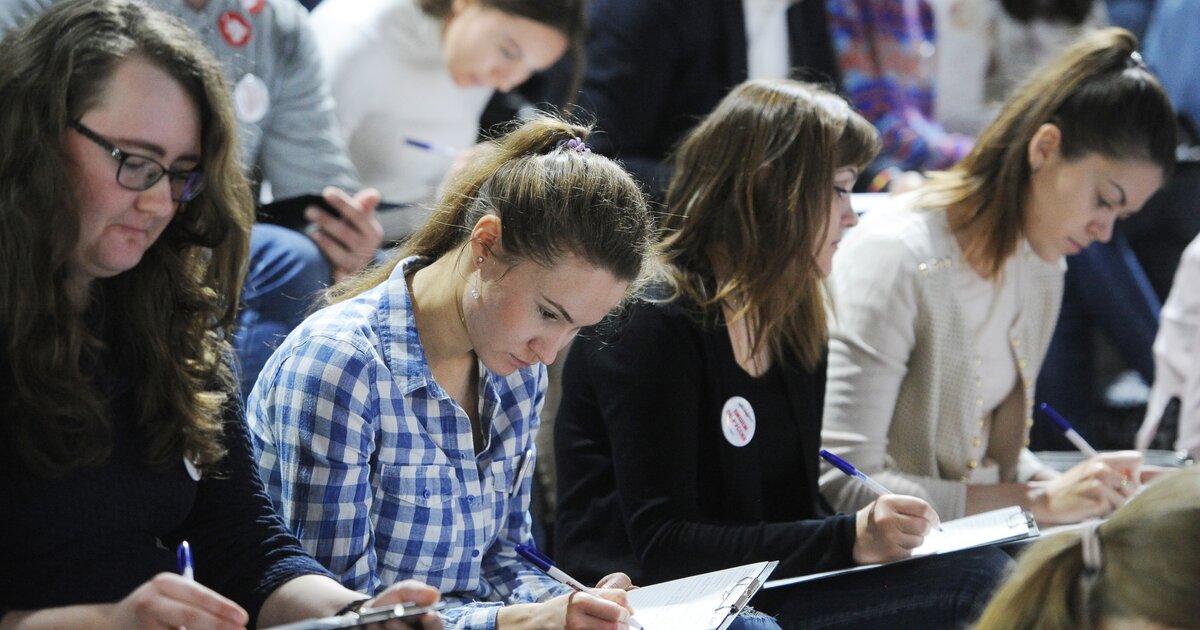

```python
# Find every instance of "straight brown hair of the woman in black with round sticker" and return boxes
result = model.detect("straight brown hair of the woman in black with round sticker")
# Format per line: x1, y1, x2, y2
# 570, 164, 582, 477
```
660, 79, 878, 370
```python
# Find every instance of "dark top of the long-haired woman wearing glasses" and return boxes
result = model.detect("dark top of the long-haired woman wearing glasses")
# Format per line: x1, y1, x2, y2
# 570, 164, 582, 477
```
0, 361, 329, 622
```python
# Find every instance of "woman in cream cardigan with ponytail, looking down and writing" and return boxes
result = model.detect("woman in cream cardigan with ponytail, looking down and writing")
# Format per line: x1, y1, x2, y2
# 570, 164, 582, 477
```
821, 29, 1175, 523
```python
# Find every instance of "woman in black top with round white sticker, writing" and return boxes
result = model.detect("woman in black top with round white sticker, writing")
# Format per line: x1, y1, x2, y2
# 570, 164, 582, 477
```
554, 80, 1007, 628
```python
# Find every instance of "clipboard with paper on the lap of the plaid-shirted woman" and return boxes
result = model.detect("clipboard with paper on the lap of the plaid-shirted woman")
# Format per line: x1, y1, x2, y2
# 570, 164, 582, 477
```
625, 562, 779, 630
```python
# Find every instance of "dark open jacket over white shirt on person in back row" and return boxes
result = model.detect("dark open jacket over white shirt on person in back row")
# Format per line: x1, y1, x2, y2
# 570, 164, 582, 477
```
553, 0, 840, 197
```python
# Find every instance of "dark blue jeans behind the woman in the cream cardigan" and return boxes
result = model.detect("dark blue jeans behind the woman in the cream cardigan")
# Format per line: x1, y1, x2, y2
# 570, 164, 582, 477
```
1030, 226, 1162, 450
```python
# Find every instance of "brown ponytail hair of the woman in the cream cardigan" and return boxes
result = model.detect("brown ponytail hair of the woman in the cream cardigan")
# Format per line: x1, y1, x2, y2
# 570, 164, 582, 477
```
919, 29, 1176, 277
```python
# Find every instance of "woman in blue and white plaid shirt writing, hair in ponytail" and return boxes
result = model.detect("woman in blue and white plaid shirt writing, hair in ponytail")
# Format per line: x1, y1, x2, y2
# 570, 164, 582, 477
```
248, 118, 652, 629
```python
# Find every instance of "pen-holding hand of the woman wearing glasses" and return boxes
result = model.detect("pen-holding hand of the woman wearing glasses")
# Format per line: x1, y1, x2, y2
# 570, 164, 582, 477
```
108, 574, 250, 630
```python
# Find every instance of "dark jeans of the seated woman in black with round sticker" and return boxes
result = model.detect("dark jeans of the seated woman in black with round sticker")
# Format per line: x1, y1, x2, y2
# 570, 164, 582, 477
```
750, 547, 1013, 630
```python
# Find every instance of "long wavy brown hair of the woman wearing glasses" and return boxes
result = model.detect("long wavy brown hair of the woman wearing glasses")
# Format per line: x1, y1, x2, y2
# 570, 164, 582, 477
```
0, 0, 253, 476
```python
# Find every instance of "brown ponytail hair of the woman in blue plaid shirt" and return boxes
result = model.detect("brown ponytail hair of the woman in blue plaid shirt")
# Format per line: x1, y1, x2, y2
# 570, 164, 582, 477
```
326, 115, 653, 304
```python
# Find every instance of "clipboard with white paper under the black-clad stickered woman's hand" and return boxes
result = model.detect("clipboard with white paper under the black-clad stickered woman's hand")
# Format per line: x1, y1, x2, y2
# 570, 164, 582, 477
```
763, 505, 1040, 588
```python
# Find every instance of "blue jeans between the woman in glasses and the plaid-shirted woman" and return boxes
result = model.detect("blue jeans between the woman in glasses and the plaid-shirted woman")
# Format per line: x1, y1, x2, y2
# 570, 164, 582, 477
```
233, 223, 332, 398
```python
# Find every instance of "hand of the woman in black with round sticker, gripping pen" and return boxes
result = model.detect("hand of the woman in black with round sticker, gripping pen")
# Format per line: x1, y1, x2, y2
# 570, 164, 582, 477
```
853, 494, 942, 564
